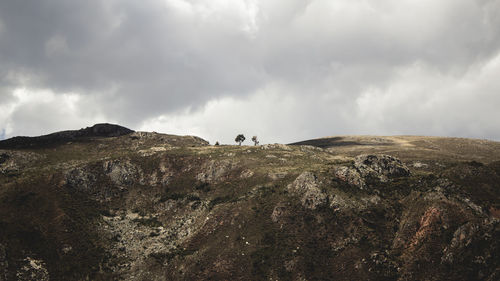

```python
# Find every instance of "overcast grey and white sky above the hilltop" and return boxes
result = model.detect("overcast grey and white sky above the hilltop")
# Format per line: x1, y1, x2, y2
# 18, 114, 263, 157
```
0, 0, 500, 143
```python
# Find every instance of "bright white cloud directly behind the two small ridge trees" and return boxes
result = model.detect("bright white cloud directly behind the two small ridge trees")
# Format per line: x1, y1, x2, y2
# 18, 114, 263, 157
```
140, 81, 305, 144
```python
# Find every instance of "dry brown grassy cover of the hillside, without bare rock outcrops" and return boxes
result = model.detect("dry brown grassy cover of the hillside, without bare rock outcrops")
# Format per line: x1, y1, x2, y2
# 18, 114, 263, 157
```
0, 132, 500, 280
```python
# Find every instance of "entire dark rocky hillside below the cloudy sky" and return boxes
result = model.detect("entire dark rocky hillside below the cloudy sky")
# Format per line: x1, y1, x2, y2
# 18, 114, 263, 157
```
0, 124, 500, 281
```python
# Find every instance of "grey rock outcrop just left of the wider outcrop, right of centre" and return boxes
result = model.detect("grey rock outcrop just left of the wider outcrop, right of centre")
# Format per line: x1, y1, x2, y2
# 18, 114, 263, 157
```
287, 172, 328, 210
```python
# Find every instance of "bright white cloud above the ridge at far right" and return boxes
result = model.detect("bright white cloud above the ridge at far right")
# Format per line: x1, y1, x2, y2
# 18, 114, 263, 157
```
356, 50, 500, 139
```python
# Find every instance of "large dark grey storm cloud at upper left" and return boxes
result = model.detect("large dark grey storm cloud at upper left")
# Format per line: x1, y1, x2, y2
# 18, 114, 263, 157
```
0, 1, 261, 118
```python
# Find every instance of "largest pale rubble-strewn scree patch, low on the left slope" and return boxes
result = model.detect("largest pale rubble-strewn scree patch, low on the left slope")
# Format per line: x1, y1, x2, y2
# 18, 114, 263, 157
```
103, 200, 208, 280
